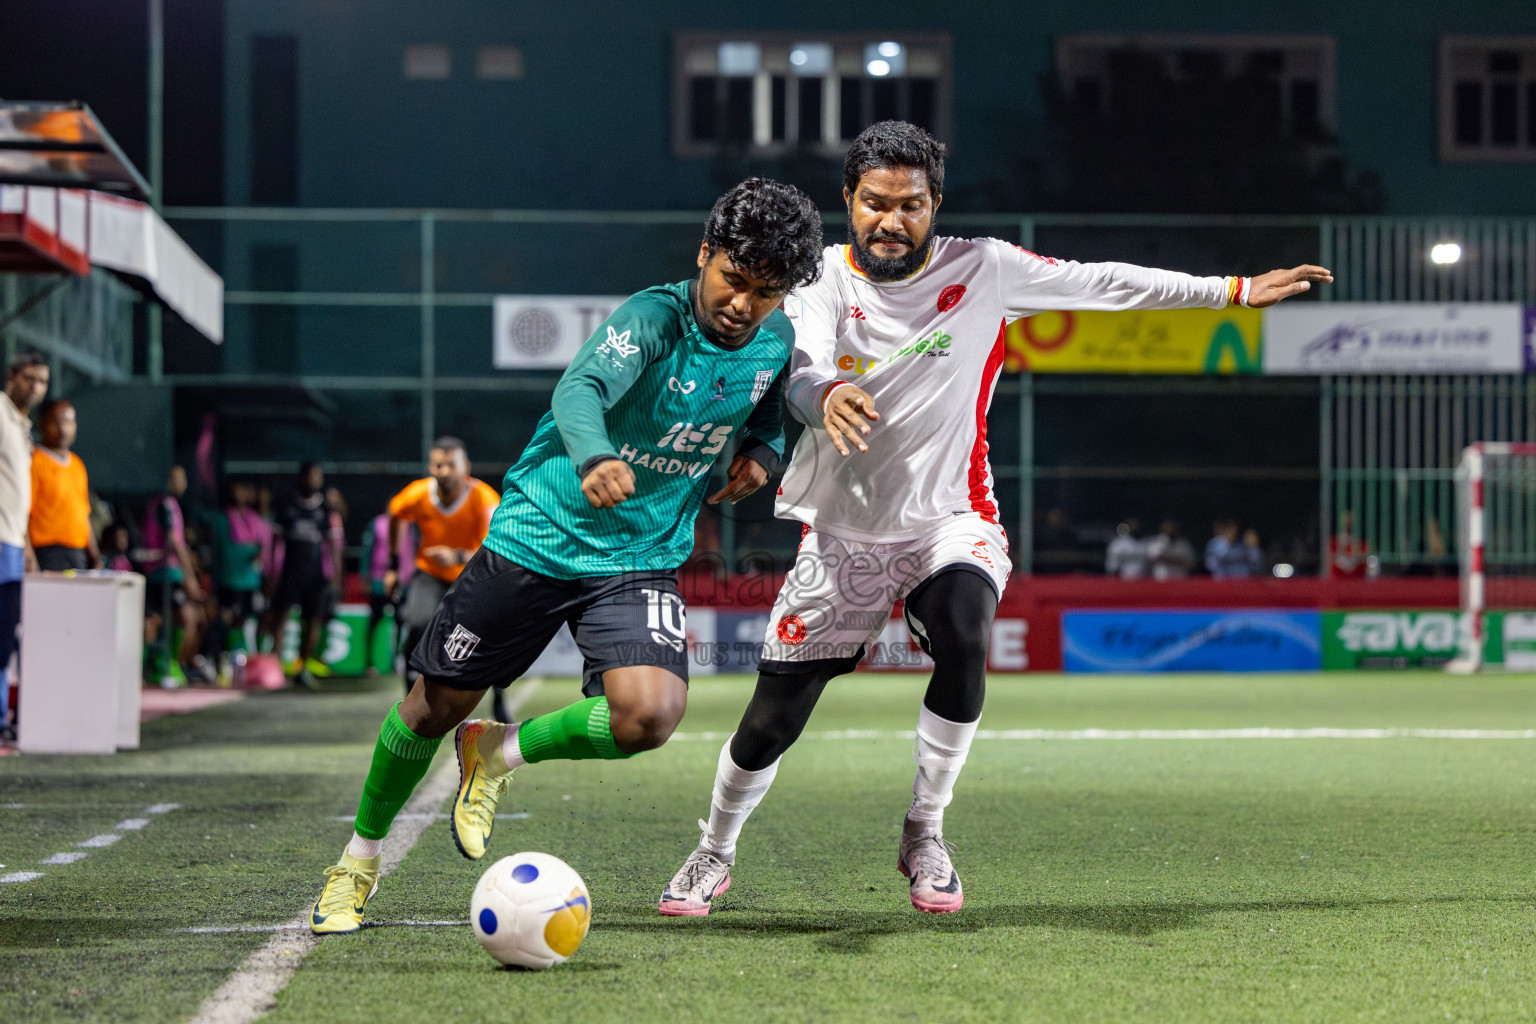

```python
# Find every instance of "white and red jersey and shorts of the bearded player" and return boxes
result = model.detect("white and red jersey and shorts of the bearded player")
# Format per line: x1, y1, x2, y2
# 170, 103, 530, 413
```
765, 238, 1250, 662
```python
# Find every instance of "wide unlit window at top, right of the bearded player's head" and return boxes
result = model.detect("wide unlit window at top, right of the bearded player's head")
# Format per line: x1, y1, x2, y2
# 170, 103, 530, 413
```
1057, 34, 1333, 138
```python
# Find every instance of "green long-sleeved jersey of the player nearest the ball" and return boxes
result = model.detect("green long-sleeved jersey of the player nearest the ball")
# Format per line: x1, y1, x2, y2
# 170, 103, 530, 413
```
485, 281, 794, 579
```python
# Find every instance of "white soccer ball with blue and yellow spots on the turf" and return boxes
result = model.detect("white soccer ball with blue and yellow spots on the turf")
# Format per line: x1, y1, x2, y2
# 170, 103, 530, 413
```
470, 854, 591, 970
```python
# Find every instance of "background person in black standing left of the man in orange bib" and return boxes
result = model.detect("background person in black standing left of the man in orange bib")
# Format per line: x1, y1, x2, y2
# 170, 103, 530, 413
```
261, 462, 346, 689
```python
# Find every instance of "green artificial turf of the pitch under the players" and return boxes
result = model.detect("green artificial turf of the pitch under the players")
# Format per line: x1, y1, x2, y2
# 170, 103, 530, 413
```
0, 672, 1536, 1024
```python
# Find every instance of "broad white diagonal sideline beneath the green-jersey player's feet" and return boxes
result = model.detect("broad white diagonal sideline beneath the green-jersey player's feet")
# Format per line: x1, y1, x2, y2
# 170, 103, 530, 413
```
189, 679, 542, 1024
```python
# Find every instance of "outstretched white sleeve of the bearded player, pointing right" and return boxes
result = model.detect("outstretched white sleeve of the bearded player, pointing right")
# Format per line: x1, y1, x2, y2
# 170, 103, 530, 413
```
985, 238, 1230, 319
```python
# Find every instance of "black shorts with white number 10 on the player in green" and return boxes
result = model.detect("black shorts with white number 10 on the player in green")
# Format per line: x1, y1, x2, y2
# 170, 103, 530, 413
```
410, 547, 688, 697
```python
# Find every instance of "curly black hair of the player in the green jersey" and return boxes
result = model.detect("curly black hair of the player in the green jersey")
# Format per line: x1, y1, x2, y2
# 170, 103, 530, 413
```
703, 178, 823, 292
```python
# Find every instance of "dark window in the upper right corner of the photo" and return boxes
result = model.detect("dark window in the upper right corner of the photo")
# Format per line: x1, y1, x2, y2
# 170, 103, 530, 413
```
1439, 35, 1536, 160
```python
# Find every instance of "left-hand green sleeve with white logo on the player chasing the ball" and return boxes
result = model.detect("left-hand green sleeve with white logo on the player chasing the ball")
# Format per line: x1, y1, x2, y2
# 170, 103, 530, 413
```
550, 292, 670, 474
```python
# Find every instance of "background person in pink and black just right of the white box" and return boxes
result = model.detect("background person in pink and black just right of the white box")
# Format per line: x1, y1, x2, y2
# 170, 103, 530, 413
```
144, 465, 214, 685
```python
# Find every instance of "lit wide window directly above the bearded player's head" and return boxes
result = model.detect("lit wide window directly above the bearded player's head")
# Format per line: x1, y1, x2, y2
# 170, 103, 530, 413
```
673, 32, 949, 157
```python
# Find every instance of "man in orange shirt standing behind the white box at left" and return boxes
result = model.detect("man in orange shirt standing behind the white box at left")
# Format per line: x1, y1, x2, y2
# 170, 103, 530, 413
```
28, 399, 101, 571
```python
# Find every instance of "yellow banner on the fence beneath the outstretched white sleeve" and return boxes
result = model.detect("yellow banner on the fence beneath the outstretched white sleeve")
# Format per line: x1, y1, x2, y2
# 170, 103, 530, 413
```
1003, 306, 1264, 375
